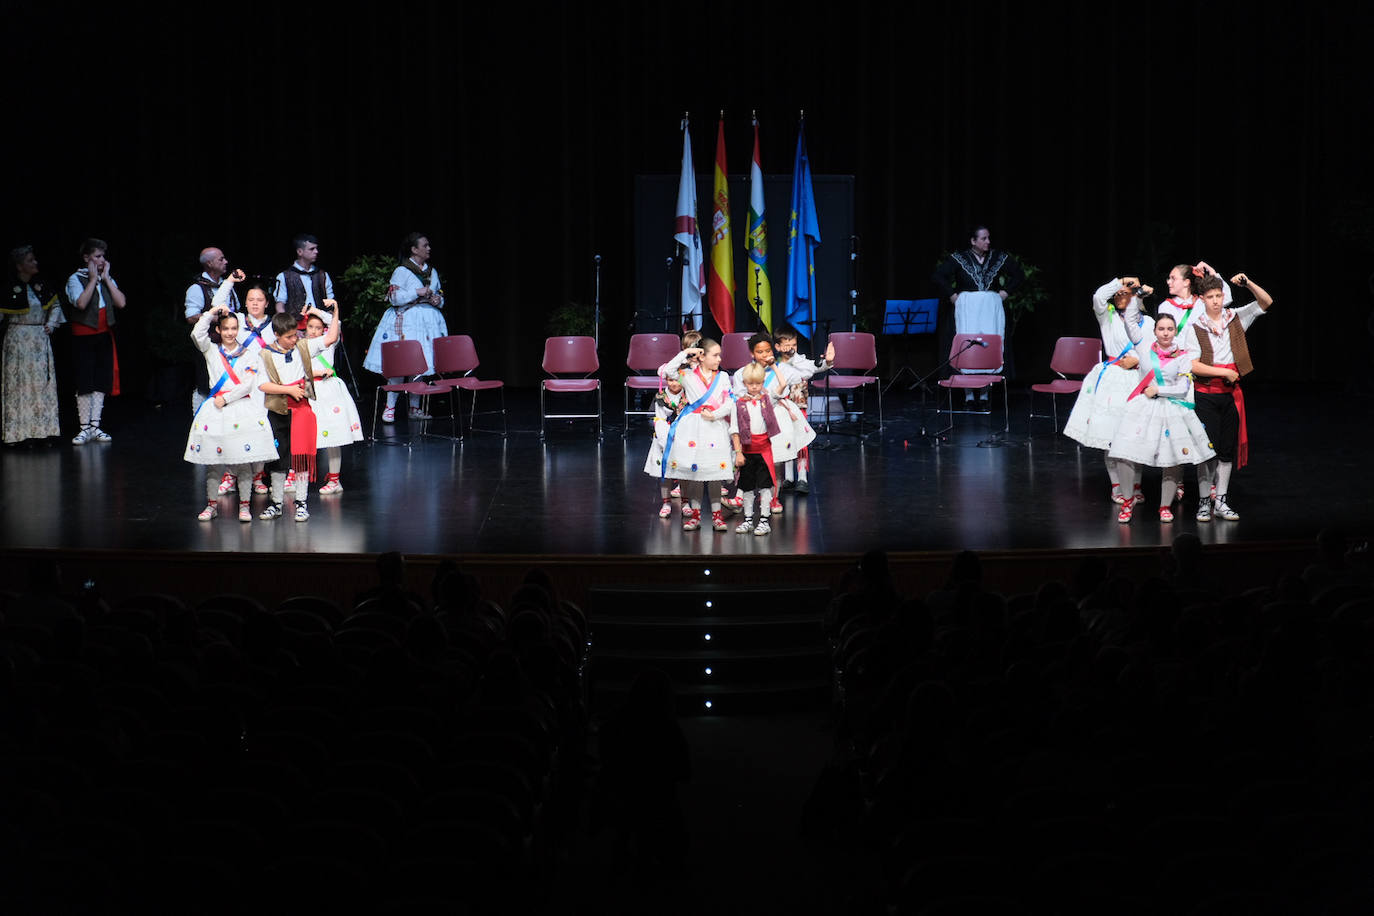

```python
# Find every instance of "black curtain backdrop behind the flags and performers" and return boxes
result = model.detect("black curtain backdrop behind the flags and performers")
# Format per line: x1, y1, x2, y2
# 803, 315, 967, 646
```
3, 0, 1374, 385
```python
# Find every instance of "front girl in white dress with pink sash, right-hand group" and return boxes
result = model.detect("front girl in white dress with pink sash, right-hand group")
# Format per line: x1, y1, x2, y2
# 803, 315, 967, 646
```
1107, 298, 1215, 523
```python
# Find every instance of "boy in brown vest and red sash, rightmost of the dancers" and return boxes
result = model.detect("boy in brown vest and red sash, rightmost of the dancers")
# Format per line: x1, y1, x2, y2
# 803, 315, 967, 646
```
1190, 273, 1274, 522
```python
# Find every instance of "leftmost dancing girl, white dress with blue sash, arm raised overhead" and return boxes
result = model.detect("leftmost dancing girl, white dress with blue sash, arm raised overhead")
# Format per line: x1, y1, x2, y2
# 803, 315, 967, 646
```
184, 301, 278, 522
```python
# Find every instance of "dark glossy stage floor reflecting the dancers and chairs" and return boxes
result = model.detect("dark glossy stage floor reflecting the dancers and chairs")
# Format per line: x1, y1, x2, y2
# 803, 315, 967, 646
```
0, 385, 1374, 555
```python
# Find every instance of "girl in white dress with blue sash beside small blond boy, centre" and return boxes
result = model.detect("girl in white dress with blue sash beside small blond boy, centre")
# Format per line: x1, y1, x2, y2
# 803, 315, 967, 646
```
658, 338, 734, 531
